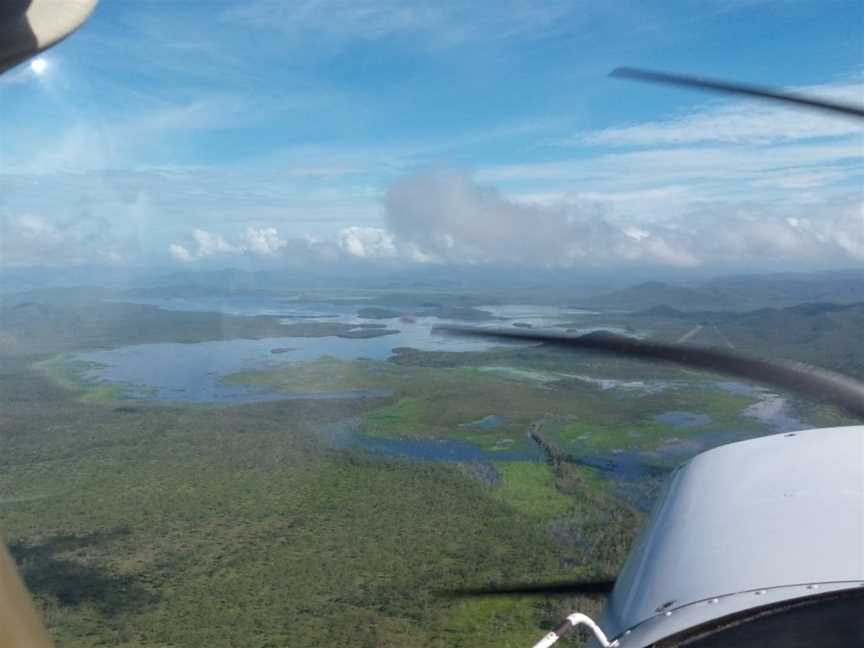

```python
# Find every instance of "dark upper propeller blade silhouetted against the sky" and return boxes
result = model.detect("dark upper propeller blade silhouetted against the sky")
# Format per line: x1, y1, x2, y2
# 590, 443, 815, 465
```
609, 67, 864, 119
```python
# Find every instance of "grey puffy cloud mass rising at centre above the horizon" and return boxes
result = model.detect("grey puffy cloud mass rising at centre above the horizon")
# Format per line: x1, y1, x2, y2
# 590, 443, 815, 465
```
385, 173, 697, 266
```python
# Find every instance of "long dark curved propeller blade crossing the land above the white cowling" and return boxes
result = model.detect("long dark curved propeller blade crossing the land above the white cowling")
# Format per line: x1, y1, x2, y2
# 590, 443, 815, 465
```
434, 326, 864, 418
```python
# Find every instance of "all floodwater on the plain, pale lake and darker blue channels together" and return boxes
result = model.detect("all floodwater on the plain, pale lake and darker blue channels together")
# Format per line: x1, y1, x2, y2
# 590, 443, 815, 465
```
66, 297, 807, 508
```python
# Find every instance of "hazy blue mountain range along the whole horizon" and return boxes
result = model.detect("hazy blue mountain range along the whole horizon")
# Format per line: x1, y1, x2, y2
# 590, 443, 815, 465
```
0, 264, 864, 311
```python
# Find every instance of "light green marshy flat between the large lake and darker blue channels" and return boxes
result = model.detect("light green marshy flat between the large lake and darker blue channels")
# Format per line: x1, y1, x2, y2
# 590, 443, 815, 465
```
225, 352, 766, 458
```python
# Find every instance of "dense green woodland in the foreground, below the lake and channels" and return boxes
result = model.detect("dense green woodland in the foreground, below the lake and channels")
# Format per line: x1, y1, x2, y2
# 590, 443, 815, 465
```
0, 360, 638, 647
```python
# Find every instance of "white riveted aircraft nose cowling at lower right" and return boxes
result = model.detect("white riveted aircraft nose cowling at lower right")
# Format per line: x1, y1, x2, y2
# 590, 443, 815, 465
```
601, 426, 864, 646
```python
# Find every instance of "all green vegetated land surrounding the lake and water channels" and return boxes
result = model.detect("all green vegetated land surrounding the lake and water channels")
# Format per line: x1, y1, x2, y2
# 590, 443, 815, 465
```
0, 286, 858, 648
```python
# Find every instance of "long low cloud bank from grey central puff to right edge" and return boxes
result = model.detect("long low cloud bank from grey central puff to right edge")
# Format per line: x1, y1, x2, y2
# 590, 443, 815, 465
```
376, 173, 864, 267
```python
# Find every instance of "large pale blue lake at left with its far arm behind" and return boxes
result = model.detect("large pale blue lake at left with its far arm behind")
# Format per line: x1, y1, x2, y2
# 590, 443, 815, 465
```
74, 297, 532, 403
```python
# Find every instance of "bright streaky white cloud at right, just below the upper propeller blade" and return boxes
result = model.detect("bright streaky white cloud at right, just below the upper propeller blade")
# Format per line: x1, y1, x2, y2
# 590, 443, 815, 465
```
510, 80, 864, 221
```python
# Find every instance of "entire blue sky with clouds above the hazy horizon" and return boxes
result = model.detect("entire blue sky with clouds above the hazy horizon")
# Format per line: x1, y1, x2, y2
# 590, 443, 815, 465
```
0, 0, 864, 271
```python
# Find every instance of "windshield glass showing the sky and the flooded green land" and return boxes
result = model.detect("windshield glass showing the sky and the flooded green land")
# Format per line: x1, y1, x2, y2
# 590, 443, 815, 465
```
0, 0, 864, 648
